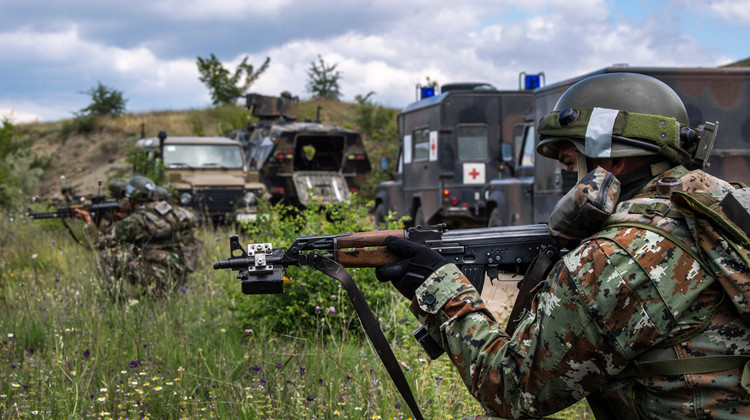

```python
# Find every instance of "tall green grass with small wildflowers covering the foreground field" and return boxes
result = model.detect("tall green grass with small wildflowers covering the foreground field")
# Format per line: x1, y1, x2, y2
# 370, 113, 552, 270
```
0, 208, 585, 419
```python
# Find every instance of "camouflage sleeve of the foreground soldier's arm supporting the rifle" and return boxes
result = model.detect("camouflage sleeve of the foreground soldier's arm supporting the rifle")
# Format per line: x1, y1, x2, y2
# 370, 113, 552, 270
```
411, 240, 659, 418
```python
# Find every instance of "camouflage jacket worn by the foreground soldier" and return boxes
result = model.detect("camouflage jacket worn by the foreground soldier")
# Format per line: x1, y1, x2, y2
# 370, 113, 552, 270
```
411, 167, 750, 418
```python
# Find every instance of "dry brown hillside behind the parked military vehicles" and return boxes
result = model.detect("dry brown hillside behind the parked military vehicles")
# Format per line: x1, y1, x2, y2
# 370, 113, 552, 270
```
18, 100, 379, 197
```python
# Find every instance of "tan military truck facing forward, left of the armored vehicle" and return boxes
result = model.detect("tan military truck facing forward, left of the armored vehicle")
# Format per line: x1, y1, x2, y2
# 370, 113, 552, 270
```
136, 131, 266, 223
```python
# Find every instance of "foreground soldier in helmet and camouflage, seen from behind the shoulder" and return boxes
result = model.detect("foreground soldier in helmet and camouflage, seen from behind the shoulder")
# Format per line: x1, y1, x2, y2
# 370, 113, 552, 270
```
376, 74, 750, 419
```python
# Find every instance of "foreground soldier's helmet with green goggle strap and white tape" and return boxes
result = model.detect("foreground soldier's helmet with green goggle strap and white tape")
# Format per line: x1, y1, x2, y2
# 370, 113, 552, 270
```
537, 73, 698, 165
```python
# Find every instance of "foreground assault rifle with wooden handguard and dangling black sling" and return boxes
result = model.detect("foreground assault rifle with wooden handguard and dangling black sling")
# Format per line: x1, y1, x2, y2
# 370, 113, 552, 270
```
214, 224, 560, 419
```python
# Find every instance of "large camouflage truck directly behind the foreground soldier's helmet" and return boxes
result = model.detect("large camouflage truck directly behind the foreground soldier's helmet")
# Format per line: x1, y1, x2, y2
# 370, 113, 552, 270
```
482, 66, 750, 226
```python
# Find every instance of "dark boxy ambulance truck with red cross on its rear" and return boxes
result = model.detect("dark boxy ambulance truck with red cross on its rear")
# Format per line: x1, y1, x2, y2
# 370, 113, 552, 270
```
373, 79, 532, 228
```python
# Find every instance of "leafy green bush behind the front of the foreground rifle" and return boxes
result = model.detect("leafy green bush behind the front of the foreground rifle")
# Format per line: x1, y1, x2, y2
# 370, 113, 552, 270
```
225, 198, 406, 335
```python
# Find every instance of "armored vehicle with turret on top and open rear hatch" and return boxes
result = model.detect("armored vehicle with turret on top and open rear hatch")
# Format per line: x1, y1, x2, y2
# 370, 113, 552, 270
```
228, 93, 371, 206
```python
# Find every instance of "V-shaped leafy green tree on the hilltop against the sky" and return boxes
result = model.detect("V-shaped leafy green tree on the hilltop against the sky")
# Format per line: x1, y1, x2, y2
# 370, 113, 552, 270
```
197, 54, 271, 106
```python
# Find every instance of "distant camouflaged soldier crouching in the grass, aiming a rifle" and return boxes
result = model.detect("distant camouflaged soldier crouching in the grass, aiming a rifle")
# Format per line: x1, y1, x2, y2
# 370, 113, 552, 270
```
74, 176, 201, 295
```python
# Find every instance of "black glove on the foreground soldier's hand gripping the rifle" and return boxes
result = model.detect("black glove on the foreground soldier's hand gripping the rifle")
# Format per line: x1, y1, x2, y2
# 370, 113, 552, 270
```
375, 236, 448, 300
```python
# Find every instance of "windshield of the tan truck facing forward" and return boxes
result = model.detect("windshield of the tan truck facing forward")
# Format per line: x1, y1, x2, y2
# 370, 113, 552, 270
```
164, 144, 243, 169
